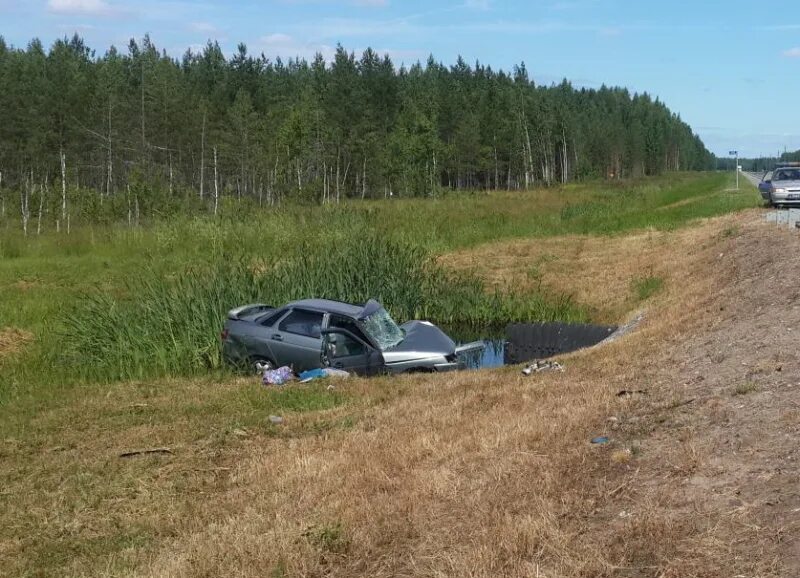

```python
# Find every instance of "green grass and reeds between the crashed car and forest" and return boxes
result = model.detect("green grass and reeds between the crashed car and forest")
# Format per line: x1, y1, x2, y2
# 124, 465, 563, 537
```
0, 169, 752, 390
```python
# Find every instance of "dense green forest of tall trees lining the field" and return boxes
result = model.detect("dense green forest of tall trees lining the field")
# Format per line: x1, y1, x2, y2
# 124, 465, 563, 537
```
0, 35, 714, 230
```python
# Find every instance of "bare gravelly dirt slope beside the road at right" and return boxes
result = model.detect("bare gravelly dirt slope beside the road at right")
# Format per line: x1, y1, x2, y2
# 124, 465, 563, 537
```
607, 212, 800, 576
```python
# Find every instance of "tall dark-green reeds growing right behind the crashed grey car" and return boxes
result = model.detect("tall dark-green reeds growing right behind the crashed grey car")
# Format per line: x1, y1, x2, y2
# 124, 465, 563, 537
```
56, 231, 586, 380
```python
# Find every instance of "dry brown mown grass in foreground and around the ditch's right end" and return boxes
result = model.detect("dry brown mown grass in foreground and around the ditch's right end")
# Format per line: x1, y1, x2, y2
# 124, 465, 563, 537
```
0, 209, 780, 577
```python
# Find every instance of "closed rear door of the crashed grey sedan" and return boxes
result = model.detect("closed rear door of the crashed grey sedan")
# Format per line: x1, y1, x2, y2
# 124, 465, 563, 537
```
270, 309, 323, 371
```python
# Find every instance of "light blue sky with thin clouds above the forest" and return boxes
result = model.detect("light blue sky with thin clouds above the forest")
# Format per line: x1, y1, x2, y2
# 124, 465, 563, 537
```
0, 0, 800, 156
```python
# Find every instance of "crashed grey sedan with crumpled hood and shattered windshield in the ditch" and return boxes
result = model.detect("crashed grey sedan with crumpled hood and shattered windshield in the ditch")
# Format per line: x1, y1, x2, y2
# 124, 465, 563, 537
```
222, 299, 481, 375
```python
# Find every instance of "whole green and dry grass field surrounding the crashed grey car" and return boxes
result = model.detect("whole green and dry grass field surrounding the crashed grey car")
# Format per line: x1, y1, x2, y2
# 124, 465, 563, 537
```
0, 174, 758, 576
